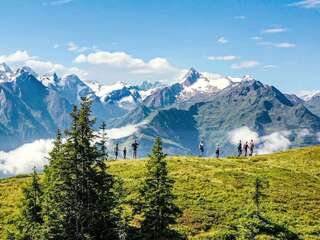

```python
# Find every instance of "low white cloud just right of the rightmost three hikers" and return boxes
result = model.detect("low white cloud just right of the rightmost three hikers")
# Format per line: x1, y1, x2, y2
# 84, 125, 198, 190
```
257, 131, 291, 154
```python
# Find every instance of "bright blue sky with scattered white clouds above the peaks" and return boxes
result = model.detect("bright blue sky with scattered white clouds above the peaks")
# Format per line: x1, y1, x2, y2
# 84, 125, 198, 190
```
0, 0, 320, 92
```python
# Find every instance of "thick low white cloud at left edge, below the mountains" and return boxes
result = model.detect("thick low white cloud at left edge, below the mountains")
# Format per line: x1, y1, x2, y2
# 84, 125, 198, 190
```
0, 139, 53, 175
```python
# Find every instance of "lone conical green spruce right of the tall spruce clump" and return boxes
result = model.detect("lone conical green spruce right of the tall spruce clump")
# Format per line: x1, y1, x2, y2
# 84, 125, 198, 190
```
135, 137, 181, 240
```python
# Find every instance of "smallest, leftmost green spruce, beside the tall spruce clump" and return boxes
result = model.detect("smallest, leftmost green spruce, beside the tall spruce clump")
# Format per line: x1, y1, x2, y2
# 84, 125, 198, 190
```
9, 168, 43, 240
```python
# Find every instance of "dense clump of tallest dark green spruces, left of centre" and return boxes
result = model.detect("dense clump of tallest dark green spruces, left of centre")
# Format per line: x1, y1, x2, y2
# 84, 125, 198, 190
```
40, 98, 118, 240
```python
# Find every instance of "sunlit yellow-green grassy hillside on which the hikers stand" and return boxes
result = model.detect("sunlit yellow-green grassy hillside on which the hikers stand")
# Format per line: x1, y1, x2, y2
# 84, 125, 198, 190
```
0, 146, 320, 239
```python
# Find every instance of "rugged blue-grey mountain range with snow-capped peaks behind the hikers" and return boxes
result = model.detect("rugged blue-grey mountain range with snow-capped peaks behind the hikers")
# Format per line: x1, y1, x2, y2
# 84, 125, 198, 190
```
0, 63, 320, 155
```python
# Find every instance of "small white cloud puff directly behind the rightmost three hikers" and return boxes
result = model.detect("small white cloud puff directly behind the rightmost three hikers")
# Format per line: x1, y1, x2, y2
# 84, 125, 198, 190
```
228, 126, 259, 144
